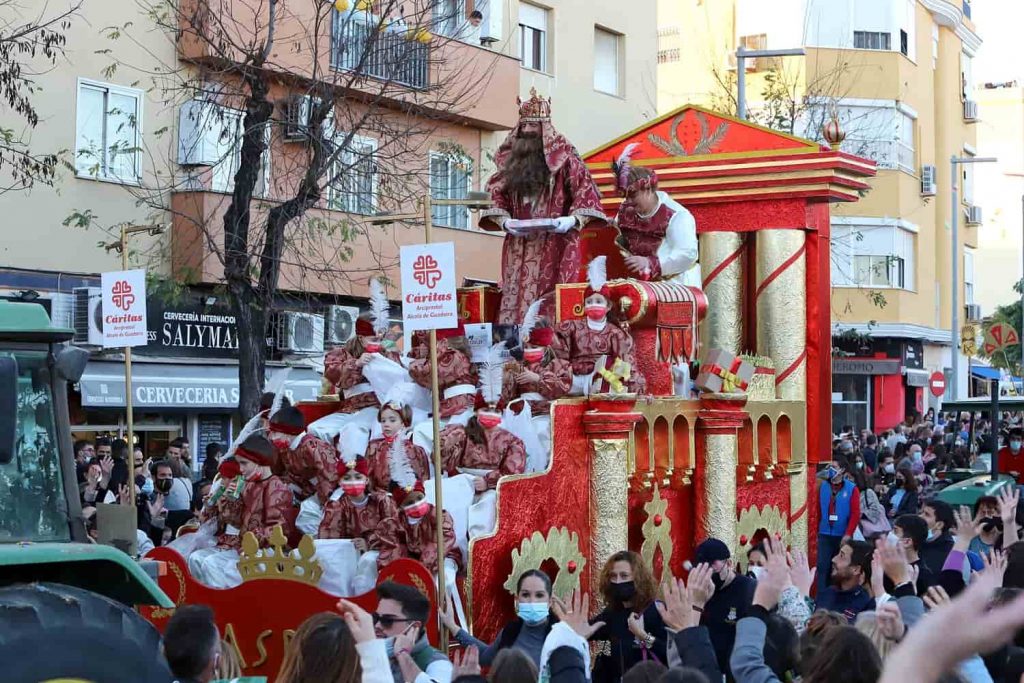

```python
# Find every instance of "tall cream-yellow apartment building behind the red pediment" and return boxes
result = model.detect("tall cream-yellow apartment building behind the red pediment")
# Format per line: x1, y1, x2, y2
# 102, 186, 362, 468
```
658, 0, 985, 429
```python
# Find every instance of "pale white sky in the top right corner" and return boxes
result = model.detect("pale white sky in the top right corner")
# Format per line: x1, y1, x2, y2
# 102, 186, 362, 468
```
971, 0, 1024, 85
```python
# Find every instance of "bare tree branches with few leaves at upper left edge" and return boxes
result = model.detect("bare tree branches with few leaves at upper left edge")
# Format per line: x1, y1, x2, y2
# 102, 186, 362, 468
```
0, 0, 82, 195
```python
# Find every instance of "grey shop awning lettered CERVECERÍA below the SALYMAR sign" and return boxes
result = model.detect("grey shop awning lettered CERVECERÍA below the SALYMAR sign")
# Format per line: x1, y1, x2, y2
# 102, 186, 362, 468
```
79, 360, 321, 410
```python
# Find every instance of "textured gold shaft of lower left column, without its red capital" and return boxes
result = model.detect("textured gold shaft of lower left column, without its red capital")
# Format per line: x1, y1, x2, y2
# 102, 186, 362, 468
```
590, 438, 630, 595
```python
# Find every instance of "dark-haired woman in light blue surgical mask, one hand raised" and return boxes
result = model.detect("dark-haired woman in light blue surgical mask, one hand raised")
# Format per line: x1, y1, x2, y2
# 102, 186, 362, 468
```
442, 569, 558, 667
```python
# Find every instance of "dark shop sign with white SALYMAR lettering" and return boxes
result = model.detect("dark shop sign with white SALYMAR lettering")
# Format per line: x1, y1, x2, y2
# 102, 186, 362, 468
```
136, 297, 239, 358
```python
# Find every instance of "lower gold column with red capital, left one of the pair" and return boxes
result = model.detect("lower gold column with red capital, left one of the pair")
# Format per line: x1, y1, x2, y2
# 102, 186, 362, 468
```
583, 399, 642, 597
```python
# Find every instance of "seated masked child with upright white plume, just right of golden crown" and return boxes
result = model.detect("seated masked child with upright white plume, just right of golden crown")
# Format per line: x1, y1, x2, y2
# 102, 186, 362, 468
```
315, 424, 398, 595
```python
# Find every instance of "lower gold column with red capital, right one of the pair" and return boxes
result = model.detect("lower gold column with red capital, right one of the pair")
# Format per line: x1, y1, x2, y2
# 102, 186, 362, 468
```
696, 393, 746, 555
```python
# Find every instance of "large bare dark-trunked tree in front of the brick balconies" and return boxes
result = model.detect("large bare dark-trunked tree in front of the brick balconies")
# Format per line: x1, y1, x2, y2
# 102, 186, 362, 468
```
71, 0, 498, 415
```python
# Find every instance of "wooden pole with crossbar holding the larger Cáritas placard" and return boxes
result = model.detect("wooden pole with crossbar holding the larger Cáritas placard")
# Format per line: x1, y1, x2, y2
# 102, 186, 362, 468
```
370, 191, 494, 652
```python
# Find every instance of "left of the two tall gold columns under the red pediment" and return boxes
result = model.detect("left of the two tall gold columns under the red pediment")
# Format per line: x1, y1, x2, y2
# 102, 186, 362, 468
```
699, 232, 744, 354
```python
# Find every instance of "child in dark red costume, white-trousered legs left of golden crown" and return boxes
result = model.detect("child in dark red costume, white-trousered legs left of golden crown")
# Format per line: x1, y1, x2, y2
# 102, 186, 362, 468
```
187, 434, 293, 588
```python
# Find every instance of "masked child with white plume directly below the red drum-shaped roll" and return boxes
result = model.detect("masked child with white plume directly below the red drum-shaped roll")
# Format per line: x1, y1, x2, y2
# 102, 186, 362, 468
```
555, 256, 643, 396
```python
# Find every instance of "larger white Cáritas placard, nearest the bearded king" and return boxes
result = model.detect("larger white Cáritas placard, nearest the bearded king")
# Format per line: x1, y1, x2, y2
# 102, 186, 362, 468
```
401, 242, 459, 332
